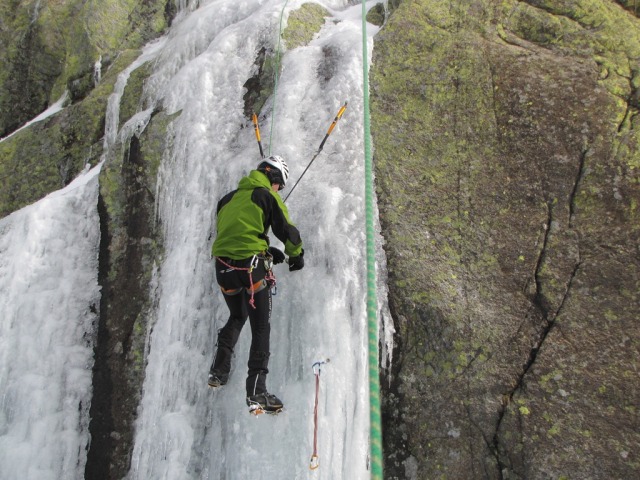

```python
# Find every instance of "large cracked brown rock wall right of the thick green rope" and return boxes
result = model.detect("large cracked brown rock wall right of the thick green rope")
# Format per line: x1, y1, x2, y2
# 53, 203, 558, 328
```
371, 0, 640, 479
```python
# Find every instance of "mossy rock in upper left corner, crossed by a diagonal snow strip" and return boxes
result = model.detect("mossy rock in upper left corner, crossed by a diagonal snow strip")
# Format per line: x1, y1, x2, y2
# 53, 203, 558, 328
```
0, 0, 176, 216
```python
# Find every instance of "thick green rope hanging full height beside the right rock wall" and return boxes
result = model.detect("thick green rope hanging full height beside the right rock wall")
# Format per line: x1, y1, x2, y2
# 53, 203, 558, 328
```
362, 0, 383, 480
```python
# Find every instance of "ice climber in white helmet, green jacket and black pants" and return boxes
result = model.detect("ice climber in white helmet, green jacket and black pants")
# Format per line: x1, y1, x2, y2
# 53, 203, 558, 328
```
208, 155, 304, 411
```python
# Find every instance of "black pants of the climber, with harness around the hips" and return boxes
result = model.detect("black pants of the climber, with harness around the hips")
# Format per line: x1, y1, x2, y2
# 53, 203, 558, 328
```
211, 258, 271, 396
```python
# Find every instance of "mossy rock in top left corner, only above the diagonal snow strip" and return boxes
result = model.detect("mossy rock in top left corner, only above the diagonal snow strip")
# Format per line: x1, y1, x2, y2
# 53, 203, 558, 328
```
0, 0, 175, 142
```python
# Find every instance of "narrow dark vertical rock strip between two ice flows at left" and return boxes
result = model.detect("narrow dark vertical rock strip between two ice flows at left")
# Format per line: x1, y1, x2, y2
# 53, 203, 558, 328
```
88, 111, 174, 478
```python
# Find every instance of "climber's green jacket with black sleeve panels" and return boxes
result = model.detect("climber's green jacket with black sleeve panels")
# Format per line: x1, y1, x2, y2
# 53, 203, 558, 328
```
211, 170, 302, 260
